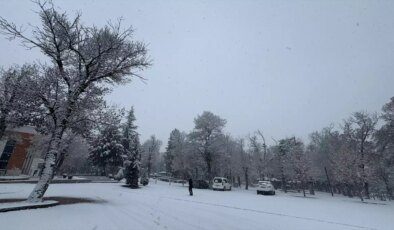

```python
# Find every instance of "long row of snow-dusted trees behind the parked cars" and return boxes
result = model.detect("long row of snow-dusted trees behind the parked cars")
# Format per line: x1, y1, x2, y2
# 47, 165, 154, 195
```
159, 103, 394, 199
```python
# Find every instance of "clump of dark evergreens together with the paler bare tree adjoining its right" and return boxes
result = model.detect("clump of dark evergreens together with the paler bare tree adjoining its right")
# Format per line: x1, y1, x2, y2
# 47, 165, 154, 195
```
85, 108, 161, 188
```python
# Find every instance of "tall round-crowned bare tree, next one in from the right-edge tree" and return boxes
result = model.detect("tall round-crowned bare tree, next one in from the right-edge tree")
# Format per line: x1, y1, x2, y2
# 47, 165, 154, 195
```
331, 115, 377, 200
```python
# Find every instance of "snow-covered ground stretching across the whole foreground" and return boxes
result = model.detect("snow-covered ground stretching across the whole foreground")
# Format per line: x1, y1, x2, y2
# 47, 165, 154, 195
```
0, 182, 394, 230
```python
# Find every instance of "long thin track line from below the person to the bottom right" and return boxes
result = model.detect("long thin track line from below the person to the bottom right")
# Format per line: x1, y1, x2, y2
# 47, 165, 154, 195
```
162, 197, 377, 230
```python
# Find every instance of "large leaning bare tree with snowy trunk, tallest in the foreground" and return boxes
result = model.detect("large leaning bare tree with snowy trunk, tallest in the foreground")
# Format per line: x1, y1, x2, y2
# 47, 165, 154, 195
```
0, 2, 150, 202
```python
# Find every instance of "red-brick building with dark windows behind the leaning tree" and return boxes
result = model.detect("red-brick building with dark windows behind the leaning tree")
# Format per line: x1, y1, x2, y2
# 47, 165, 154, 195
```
0, 126, 44, 176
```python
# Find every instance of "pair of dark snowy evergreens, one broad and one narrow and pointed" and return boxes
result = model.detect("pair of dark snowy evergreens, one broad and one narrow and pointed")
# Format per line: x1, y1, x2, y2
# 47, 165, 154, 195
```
89, 108, 141, 188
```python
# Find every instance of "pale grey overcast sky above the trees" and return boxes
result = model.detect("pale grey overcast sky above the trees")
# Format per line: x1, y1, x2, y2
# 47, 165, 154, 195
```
0, 0, 394, 144
